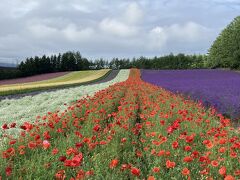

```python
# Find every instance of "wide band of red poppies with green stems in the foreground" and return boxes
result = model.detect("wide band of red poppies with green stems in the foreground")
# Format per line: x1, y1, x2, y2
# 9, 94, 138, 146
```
0, 69, 240, 180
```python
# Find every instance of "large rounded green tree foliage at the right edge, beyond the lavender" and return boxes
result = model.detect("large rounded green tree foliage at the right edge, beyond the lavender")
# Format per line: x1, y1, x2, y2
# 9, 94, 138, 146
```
207, 16, 240, 69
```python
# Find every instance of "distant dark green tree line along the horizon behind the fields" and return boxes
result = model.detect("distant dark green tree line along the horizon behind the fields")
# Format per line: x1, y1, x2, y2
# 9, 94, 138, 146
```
0, 51, 207, 79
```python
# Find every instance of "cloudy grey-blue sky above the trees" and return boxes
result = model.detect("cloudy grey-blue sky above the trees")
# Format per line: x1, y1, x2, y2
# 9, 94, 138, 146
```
0, 0, 240, 62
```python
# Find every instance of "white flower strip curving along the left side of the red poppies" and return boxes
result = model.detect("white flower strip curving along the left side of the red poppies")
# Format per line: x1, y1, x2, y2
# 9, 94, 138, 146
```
0, 70, 129, 134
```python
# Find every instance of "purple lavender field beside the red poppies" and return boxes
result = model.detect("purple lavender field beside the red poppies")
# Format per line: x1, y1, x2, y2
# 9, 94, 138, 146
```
142, 70, 240, 119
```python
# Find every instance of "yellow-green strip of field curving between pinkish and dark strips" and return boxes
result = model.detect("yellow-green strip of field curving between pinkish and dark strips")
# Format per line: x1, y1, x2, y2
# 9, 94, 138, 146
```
0, 69, 110, 95
